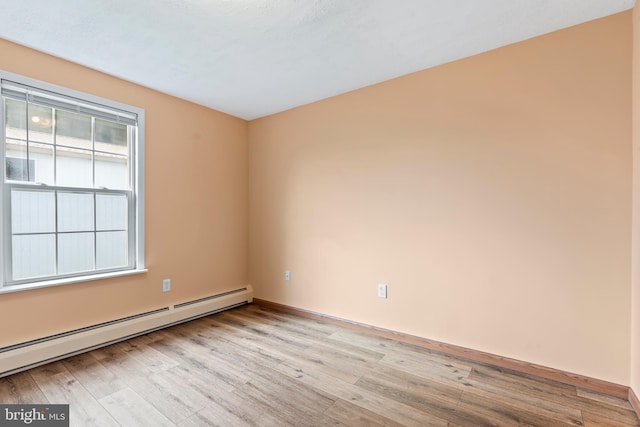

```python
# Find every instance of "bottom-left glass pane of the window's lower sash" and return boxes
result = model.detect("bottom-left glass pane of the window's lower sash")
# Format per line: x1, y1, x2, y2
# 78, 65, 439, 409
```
11, 234, 56, 280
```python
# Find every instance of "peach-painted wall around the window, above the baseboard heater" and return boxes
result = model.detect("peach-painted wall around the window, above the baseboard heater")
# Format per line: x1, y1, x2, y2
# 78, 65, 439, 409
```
0, 40, 248, 346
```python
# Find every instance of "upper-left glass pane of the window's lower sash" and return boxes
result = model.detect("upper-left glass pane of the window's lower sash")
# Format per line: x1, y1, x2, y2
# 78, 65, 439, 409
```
11, 190, 56, 234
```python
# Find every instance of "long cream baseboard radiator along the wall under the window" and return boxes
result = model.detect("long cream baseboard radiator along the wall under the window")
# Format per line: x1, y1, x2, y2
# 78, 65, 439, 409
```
0, 285, 253, 378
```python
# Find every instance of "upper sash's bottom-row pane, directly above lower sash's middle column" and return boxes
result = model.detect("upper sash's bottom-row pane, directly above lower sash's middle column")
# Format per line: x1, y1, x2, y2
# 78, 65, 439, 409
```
56, 147, 93, 187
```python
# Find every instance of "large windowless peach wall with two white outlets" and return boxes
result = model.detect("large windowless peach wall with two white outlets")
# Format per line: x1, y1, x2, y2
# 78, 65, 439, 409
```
249, 12, 631, 384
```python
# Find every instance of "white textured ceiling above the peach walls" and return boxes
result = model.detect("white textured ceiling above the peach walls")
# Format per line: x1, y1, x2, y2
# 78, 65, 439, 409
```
0, 0, 635, 119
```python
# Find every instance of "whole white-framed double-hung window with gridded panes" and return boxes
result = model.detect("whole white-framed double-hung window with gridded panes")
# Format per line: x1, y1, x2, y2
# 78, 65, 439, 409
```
0, 72, 144, 291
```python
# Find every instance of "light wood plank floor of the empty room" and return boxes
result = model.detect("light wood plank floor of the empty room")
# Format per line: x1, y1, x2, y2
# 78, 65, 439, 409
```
0, 305, 640, 427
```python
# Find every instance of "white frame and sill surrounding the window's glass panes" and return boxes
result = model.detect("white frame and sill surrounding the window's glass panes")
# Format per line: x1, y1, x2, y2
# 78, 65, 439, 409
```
0, 70, 147, 294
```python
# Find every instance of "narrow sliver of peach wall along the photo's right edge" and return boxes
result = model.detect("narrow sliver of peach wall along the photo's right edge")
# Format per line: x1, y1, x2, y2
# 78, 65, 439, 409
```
631, 4, 640, 396
